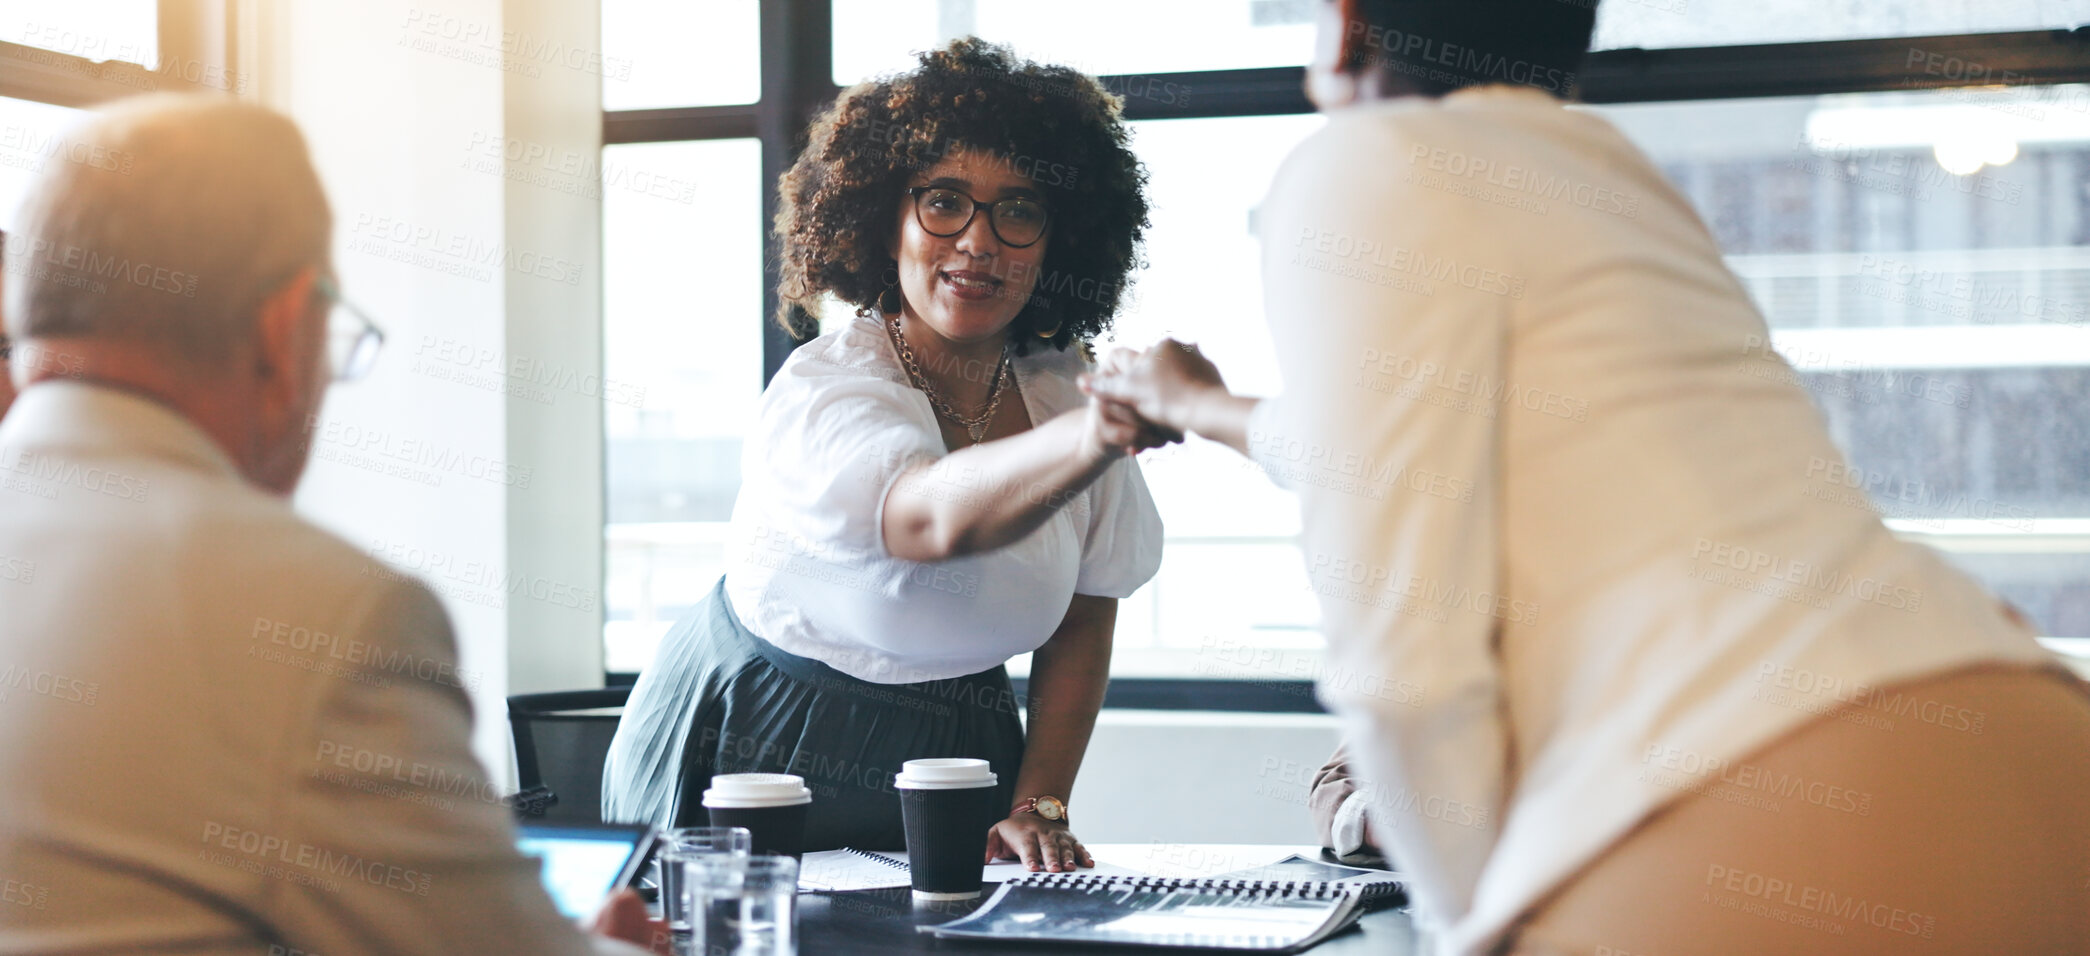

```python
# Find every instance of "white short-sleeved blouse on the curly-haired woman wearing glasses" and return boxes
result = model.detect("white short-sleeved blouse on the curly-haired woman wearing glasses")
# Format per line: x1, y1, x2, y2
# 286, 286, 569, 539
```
725, 316, 1162, 684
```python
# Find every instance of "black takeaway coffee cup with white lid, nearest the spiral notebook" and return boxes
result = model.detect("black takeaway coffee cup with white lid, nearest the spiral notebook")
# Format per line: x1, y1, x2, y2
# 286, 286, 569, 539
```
892, 757, 1001, 900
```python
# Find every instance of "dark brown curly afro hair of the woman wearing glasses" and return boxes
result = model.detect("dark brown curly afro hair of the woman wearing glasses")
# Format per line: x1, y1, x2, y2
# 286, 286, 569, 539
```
775, 38, 1150, 354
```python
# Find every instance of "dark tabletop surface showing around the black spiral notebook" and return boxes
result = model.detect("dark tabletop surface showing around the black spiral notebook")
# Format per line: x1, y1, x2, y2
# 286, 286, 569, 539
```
798, 885, 1415, 956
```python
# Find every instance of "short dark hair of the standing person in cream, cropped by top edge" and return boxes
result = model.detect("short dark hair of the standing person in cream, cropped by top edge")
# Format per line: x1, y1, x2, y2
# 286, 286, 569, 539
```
1342, 0, 1599, 98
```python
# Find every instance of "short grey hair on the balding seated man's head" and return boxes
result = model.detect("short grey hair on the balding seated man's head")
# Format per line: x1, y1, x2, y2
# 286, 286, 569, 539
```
6, 94, 332, 366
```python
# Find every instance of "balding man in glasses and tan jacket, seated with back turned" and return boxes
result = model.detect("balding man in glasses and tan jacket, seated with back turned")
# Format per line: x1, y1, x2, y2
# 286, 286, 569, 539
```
0, 96, 648, 956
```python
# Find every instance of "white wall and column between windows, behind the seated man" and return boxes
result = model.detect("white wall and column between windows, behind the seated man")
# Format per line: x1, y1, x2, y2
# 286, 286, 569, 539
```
238, 0, 602, 776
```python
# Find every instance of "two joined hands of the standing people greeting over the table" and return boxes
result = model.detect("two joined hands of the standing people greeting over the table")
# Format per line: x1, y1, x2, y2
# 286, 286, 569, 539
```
1078, 339, 1237, 456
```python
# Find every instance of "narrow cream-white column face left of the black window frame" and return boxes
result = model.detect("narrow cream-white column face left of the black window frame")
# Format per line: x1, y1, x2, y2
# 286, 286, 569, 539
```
502, 0, 606, 695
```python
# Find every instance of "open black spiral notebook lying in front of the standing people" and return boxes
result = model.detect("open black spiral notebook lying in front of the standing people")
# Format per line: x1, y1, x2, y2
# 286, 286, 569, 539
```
922, 856, 1400, 952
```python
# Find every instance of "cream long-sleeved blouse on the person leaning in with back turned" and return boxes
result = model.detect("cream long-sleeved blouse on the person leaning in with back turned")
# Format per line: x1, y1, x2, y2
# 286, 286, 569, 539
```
1248, 88, 2052, 954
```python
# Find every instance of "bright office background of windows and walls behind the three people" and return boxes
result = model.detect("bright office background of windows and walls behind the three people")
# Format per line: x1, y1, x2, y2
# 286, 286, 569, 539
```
0, 0, 2090, 843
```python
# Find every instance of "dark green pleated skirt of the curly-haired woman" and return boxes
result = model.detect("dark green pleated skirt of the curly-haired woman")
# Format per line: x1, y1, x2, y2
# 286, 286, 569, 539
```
602, 579, 1024, 849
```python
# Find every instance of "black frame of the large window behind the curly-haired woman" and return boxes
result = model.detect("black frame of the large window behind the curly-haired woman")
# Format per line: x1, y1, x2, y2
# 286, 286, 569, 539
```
597, 0, 2090, 713
